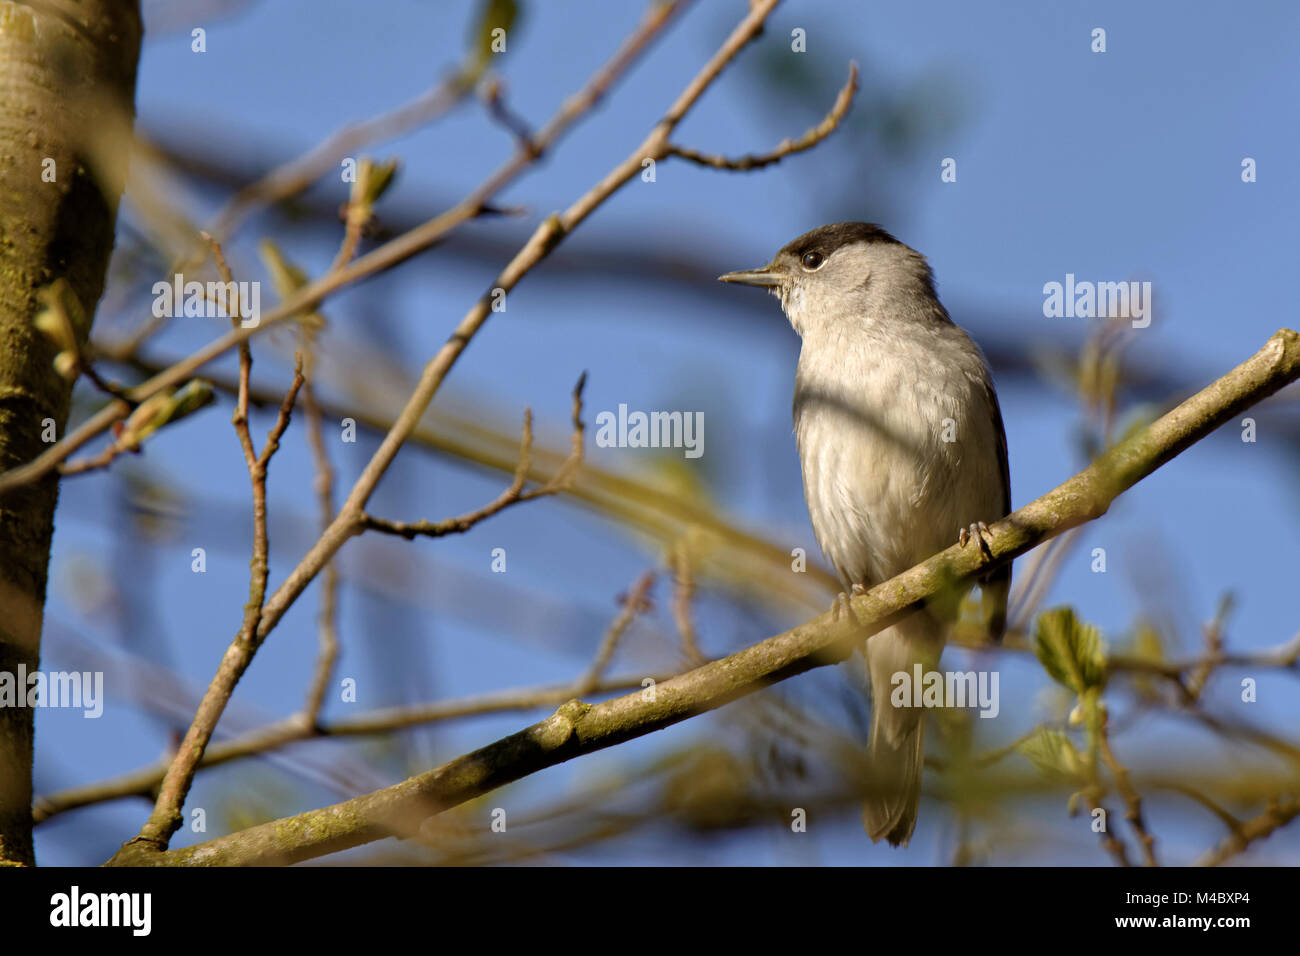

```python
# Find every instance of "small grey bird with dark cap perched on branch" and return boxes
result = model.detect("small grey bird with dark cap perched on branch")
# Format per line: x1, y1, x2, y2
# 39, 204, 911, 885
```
719, 222, 1011, 847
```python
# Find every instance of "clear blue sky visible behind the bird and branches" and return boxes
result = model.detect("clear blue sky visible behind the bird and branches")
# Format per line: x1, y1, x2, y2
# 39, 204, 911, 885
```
36, 0, 1300, 864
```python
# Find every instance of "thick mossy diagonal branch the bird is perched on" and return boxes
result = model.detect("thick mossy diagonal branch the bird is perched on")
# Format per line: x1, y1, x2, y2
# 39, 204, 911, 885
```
111, 329, 1300, 866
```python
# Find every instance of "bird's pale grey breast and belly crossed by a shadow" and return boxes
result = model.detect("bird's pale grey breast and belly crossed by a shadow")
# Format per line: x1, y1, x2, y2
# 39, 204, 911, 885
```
794, 323, 1005, 585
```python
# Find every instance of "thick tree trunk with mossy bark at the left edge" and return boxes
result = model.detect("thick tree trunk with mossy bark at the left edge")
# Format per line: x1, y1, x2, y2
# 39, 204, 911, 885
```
0, 0, 142, 865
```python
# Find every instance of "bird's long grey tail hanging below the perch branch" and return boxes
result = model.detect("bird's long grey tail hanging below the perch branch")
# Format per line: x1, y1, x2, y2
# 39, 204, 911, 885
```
862, 610, 943, 847
